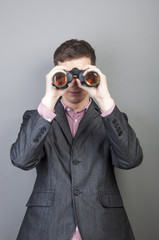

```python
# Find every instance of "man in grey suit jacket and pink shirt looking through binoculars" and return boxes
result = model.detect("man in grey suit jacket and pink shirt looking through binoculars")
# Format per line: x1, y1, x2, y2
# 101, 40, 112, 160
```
11, 39, 142, 240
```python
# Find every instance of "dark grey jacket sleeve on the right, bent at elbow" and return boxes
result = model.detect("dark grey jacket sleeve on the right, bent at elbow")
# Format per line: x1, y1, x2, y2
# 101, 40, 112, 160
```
103, 107, 143, 169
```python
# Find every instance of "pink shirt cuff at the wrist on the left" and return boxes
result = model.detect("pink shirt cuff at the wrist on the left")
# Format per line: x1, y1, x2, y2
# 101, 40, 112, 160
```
37, 103, 56, 122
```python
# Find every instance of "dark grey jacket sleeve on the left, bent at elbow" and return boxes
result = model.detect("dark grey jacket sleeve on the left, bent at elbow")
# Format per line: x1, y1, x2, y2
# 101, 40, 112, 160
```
10, 110, 50, 170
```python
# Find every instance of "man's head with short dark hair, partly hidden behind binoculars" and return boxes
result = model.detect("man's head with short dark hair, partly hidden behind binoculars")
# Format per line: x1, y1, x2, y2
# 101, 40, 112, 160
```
54, 39, 96, 109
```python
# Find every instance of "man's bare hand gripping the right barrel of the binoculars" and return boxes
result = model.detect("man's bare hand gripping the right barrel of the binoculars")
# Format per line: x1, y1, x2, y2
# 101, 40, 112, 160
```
77, 65, 114, 111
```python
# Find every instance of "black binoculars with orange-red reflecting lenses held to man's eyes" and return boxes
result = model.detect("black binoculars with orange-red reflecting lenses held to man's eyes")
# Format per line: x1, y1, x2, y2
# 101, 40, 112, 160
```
52, 68, 100, 88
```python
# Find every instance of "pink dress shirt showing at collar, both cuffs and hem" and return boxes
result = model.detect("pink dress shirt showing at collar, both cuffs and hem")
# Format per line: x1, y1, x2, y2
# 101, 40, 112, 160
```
38, 99, 115, 240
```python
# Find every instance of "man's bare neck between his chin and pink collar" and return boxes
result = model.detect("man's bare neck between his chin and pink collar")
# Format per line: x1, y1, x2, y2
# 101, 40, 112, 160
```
62, 96, 89, 112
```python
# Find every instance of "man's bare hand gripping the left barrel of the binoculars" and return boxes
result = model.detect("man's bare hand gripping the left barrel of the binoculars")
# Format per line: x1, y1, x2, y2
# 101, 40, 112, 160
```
42, 65, 69, 110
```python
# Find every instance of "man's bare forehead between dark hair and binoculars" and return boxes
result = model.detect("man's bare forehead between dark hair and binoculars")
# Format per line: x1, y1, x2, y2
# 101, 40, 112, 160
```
58, 57, 91, 70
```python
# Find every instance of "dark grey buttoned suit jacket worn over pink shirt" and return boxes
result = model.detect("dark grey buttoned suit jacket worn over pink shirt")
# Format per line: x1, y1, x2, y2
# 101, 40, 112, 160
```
11, 98, 142, 240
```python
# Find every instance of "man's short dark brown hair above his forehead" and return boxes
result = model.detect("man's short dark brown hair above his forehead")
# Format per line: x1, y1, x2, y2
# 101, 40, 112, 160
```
54, 39, 96, 66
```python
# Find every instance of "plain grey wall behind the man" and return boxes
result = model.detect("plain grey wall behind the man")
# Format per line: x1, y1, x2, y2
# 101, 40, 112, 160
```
0, 0, 159, 240
